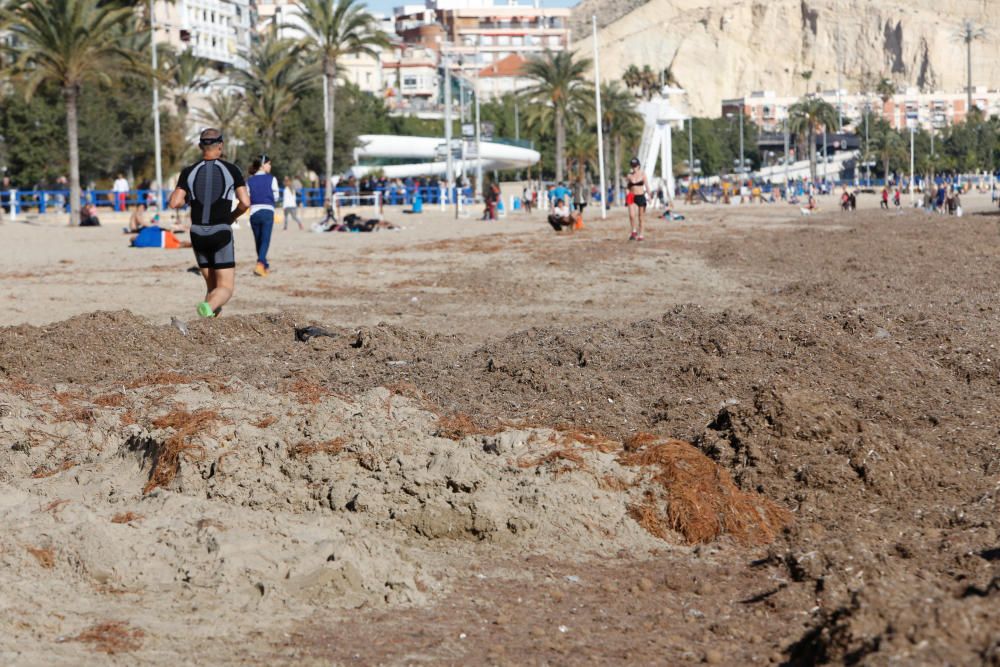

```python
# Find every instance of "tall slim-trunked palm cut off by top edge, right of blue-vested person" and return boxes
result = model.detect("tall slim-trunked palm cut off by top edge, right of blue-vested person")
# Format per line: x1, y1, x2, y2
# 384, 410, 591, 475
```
299, 0, 389, 202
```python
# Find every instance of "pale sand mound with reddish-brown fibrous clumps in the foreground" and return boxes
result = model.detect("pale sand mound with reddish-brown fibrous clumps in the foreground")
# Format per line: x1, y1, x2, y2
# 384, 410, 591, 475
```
0, 372, 788, 653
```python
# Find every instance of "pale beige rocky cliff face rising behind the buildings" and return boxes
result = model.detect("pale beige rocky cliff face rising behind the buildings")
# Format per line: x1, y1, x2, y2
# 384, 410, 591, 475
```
573, 0, 1000, 115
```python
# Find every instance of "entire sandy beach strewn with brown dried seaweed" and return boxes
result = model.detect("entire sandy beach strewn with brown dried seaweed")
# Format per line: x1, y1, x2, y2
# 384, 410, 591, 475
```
0, 195, 1000, 665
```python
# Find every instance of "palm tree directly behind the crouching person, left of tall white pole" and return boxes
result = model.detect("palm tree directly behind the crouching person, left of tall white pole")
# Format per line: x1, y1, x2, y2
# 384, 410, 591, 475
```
521, 50, 590, 181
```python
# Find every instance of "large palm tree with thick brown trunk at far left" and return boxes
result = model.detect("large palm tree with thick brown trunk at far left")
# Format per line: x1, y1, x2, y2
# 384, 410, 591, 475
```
0, 0, 136, 225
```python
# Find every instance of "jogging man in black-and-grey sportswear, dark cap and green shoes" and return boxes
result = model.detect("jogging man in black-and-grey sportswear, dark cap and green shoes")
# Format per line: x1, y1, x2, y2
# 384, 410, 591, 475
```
169, 128, 250, 317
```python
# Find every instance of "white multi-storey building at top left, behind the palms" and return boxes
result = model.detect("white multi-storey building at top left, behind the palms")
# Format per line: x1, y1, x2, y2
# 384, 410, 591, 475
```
154, 0, 253, 67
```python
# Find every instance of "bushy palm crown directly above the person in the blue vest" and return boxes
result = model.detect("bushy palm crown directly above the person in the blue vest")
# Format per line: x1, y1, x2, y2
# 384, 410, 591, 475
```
234, 30, 315, 150
